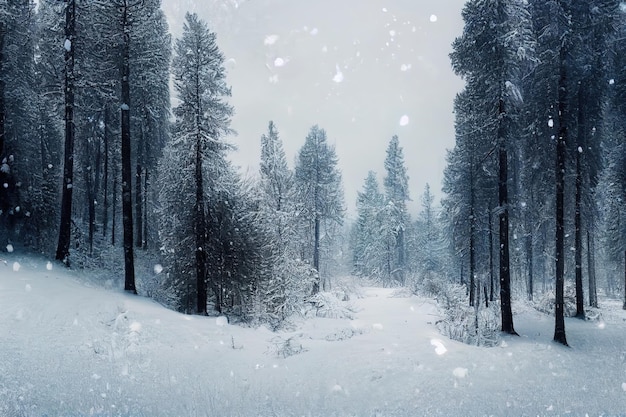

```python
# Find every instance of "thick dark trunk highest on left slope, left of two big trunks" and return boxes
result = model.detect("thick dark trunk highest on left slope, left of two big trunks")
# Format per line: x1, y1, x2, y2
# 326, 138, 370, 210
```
55, 0, 76, 266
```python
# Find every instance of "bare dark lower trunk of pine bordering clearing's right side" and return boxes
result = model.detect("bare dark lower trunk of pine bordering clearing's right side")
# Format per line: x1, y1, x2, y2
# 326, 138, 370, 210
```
498, 99, 517, 334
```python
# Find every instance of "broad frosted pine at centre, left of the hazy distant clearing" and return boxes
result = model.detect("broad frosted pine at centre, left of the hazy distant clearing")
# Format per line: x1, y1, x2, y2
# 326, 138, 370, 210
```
295, 125, 344, 294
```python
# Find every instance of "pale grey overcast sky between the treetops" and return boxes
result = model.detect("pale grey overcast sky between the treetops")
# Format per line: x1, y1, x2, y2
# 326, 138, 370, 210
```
158, 0, 465, 216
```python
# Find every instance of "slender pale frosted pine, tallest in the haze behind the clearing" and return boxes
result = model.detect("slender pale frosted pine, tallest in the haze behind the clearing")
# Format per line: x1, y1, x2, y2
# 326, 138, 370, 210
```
383, 135, 410, 285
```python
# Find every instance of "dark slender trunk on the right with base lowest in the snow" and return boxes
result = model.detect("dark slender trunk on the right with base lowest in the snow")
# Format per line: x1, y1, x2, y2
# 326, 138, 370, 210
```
554, 47, 567, 346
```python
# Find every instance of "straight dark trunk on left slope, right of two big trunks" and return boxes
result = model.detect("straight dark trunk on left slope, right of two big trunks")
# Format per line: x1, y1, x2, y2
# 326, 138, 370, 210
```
121, 5, 137, 294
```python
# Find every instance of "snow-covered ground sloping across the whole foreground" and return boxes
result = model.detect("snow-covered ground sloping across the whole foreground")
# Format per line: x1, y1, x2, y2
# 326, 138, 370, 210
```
0, 254, 626, 417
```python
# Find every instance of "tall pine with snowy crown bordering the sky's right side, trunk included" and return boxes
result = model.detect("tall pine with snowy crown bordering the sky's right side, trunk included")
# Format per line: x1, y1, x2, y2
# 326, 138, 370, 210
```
450, 0, 535, 334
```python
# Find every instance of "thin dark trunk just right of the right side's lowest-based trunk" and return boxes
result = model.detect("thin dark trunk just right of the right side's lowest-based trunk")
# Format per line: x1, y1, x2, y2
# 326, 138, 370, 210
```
574, 83, 585, 319
